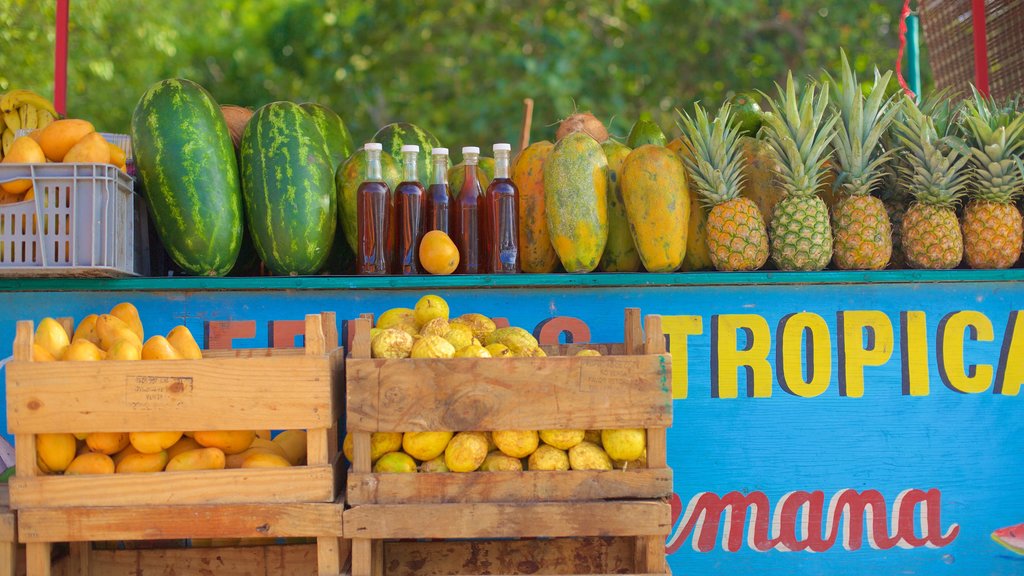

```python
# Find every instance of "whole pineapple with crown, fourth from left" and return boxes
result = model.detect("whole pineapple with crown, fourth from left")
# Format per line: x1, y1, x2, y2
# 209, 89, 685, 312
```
894, 97, 970, 270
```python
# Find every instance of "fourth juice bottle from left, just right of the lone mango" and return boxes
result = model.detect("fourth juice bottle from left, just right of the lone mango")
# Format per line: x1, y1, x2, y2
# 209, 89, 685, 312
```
452, 146, 486, 274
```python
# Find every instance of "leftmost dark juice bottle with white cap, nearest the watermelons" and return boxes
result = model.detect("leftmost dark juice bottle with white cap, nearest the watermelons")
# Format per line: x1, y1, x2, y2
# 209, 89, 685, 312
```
355, 142, 394, 275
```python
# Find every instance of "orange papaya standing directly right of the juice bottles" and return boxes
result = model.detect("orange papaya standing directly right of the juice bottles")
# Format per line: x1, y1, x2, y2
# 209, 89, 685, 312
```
512, 140, 558, 274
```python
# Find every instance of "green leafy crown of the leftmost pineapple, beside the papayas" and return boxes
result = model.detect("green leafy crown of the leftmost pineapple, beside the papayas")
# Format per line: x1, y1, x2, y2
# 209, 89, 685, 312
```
676, 102, 743, 209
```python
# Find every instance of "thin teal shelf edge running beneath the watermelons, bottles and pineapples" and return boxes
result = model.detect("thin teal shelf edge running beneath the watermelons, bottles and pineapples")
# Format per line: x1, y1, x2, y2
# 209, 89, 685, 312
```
0, 269, 1024, 292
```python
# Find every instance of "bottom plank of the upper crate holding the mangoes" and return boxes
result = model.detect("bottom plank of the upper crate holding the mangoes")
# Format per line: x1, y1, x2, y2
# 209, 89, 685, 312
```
9, 465, 334, 509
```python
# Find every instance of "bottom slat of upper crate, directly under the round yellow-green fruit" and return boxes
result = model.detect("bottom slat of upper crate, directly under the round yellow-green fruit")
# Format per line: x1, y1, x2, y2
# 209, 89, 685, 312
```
345, 467, 673, 505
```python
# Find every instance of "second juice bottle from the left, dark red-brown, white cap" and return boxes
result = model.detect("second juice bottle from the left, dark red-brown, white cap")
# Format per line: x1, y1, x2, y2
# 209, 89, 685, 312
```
394, 145, 426, 274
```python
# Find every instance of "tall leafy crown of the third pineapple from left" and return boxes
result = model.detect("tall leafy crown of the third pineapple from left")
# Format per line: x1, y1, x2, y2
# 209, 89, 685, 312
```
826, 51, 899, 196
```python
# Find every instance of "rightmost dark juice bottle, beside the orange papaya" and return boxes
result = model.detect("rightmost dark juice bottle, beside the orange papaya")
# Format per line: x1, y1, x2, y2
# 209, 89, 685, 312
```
483, 143, 519, 274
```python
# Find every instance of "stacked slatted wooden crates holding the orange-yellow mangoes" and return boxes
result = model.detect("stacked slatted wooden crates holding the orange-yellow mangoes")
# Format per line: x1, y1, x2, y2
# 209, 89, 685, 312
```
7, 313, 344, 576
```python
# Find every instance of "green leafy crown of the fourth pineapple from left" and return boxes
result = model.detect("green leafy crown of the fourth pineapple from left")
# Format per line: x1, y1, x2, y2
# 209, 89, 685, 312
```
894, 97, 971, 208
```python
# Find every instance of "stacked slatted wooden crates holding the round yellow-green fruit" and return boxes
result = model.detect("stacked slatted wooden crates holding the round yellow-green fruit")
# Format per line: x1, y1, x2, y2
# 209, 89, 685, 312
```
345, 308, 672, 576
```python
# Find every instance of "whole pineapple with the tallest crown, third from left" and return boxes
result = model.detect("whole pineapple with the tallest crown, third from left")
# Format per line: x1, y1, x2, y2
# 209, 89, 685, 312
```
833, 52, 897, 270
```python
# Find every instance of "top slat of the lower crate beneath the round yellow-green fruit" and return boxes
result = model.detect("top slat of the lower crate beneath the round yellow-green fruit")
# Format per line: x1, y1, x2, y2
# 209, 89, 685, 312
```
345, 501, 672, 537
